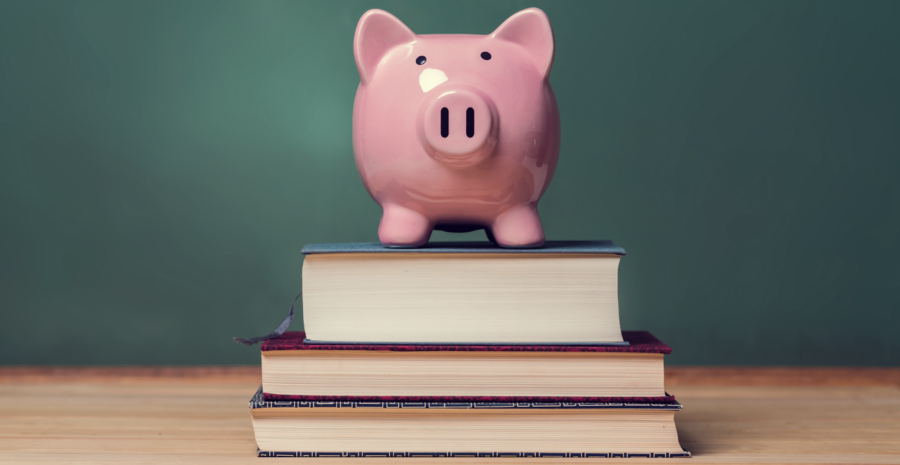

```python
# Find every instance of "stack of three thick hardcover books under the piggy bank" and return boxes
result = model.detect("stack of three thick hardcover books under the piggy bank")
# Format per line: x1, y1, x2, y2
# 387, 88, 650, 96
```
250, 241, 690, 457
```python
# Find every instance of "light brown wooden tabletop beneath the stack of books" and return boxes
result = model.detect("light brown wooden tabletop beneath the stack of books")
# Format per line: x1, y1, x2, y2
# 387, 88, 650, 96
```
0, 367, 900, 465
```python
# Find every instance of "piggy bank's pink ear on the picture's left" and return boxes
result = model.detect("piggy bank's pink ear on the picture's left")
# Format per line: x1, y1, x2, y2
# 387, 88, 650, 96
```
353, 10, 416, 84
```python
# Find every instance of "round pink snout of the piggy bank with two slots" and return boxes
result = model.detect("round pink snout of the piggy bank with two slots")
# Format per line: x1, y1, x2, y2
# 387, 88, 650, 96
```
421, 89, 498, 166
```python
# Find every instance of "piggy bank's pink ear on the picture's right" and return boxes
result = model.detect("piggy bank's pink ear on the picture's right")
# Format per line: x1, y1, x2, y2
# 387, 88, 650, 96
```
491, 8, 556, 78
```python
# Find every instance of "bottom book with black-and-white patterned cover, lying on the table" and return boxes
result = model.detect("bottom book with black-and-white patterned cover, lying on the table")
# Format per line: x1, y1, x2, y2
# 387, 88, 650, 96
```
250, 389, 690, 457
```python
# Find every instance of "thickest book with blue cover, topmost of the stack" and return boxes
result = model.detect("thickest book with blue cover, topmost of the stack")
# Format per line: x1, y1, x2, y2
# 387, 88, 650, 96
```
301, 241, 627, 345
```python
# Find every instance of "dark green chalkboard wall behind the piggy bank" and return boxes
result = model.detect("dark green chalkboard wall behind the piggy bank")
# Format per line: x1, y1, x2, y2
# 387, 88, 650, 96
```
0, 0, 900, 365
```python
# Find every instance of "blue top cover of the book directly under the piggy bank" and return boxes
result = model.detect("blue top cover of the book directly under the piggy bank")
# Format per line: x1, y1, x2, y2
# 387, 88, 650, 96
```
300, 241, 625, 255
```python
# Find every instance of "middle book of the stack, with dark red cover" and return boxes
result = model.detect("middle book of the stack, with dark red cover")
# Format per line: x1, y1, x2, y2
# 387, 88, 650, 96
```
260, 331, 674, 403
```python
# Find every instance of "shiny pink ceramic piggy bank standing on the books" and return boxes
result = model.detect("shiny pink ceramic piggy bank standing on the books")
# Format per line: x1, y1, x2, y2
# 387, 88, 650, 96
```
353, 8, 560, 248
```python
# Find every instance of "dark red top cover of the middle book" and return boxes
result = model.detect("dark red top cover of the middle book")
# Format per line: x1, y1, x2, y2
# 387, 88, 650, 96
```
259, 331, 672, 354
